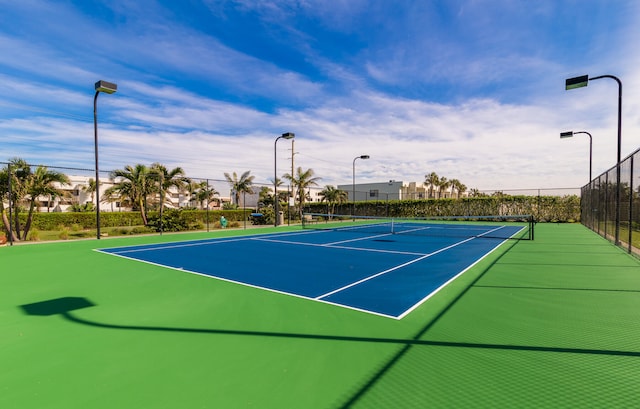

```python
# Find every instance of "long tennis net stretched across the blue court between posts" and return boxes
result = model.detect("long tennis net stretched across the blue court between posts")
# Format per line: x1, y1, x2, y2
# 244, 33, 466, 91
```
302, 213, 535, 240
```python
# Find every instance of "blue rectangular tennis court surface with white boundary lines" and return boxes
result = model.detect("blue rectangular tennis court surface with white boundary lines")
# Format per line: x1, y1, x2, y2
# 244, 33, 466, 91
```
99, 226, 522, 319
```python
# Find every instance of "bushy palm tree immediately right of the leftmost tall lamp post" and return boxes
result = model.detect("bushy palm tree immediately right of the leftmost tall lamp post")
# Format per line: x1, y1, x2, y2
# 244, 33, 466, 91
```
105, 163, 157, 226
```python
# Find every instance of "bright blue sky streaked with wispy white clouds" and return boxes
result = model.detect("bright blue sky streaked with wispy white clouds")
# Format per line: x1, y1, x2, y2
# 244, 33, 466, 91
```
0, 0, 640, 190
